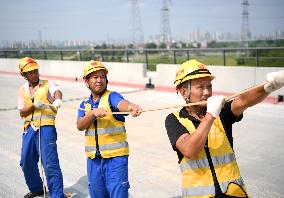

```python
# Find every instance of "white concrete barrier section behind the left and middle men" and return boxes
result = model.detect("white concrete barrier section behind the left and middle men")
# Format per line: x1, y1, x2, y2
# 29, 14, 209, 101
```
0, 58, 147, 84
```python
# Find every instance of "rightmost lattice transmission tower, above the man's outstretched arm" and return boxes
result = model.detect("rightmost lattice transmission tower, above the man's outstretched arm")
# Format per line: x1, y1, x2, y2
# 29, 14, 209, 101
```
241, 0, 251, 47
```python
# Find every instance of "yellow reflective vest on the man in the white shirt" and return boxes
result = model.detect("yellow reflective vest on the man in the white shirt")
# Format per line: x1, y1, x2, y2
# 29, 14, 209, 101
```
21, 80, 56, 130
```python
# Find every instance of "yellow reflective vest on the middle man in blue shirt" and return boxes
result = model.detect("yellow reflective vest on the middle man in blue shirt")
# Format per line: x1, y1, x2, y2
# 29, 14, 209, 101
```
85, 90, 129, 159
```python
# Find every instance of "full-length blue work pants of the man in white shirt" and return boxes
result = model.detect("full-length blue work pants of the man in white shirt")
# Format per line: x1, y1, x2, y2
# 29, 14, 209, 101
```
20, 126, 64, 198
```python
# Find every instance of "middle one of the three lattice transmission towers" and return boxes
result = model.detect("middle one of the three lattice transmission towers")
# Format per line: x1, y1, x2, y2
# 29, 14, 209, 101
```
160, 0, 171, 44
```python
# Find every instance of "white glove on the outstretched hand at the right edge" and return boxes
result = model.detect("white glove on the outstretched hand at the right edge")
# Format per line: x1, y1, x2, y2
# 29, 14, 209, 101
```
264, 70, 284, 93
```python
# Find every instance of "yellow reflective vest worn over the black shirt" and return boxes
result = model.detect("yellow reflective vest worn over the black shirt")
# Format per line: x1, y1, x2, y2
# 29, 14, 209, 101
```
174, 112, 245, 198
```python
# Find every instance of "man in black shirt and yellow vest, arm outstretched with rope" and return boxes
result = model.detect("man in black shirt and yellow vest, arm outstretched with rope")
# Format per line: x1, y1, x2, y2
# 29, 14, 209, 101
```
165, 60, 284, 198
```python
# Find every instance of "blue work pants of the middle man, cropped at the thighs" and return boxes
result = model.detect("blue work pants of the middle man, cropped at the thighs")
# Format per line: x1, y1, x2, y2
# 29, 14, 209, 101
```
87, 156, 130, 198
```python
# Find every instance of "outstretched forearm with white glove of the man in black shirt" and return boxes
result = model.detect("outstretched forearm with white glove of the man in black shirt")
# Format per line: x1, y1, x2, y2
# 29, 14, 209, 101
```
231, 70, 284, 116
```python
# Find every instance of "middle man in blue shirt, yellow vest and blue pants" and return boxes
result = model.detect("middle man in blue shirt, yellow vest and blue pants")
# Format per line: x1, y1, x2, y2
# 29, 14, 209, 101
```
77, 60, 142, 198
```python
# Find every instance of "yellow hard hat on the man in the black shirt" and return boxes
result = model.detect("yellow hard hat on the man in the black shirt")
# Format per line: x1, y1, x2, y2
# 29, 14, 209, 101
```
174, 59, 215, 87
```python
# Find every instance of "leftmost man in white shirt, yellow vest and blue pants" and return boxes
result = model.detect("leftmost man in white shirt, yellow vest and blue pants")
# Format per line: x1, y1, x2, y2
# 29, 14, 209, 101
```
18, 57, 64, 198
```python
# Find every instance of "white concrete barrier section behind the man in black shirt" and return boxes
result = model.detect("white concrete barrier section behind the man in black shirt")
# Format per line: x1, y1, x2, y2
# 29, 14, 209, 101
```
155, 64, 284, 96
